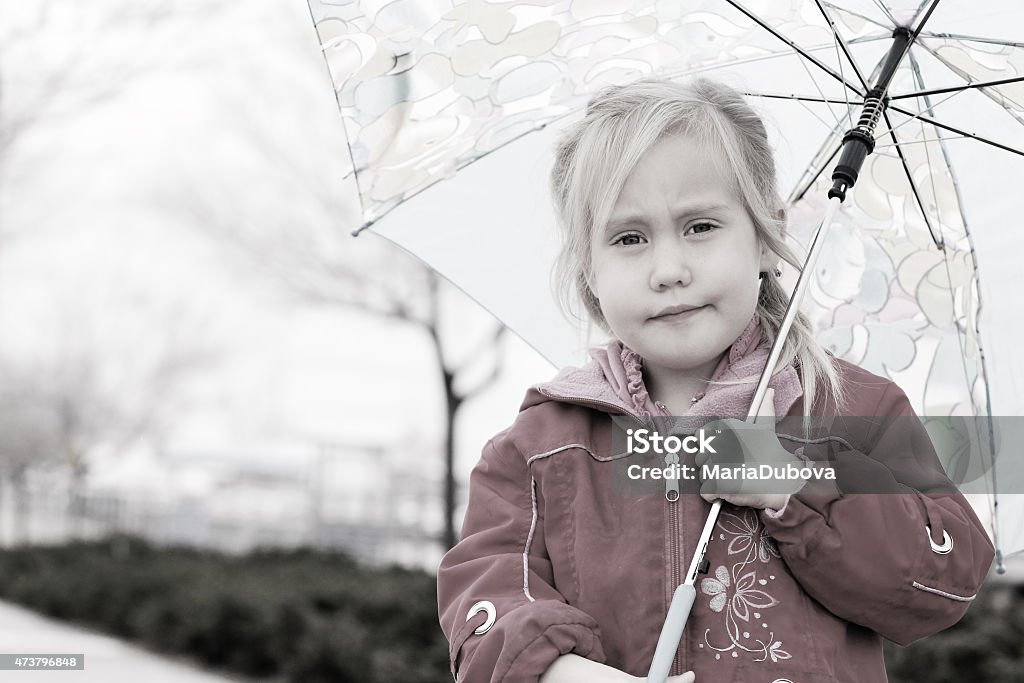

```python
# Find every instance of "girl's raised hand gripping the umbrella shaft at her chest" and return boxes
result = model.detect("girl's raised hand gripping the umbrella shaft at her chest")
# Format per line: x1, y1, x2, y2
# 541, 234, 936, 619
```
696, 389, 806, 510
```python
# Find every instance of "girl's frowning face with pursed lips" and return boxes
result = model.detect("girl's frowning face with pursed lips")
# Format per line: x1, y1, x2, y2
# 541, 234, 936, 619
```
591, 135, 778, 379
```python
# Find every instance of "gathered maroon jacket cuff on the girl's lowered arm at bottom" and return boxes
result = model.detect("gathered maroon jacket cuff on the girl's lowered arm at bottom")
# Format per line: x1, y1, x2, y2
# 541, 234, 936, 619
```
450, 600, 605, 683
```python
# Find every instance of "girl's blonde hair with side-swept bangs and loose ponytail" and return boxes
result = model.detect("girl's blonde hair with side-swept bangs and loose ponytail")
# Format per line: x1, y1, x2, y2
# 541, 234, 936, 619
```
551, 79, 844, 415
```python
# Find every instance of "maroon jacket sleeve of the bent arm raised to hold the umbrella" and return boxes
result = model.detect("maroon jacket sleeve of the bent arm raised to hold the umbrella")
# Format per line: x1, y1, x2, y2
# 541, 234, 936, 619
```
761, 384, 994, 645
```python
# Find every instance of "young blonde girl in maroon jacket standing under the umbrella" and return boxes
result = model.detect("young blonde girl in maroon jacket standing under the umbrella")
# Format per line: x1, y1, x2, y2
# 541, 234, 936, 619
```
437, 80, 993, 683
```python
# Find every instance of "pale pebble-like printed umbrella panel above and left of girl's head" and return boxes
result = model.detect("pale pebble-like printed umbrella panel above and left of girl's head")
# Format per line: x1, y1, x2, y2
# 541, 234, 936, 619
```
309, 0, 889, 224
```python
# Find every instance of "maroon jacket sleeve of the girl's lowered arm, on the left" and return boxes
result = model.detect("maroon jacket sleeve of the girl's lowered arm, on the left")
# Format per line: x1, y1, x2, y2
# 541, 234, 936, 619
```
437, 432, 604, 683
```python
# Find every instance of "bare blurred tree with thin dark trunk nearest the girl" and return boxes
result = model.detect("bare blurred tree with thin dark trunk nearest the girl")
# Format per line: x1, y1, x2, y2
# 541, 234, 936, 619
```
157, 2, 505, 549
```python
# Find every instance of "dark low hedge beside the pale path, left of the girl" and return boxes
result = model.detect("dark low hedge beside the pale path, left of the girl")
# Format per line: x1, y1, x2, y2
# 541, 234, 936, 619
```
0, 537, 450, 683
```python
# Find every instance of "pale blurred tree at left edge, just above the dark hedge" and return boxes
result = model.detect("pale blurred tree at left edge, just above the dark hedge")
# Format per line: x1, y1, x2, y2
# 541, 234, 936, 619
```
0, 292, 217, 542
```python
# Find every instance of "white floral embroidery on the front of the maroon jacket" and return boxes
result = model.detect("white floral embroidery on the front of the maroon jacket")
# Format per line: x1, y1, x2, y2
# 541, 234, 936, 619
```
700, 508, 792, 661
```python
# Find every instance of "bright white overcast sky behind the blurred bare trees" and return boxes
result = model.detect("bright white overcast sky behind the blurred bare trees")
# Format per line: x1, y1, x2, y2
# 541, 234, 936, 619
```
0, 0, 553, 501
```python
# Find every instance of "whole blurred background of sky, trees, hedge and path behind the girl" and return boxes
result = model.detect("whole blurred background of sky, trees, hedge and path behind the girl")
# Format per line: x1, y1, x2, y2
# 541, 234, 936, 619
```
0, 0, 1024, 681
